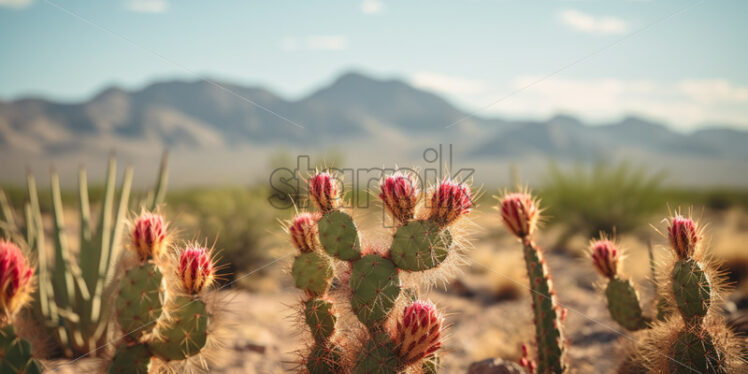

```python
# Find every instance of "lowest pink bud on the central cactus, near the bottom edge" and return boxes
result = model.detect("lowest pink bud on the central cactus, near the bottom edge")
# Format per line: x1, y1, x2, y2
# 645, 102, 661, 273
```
397, 301, 444, 366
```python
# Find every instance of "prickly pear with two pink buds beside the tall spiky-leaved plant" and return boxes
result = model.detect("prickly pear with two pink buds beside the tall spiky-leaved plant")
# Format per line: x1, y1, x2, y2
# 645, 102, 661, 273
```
109, 212, 215, 373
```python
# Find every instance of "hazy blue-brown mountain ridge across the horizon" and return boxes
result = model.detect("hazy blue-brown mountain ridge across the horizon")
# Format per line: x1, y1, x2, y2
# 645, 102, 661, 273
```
0, 73, 748, 186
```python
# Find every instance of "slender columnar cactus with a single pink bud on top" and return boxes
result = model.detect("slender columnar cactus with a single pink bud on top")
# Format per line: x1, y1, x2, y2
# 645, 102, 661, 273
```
499, 192, 568, 374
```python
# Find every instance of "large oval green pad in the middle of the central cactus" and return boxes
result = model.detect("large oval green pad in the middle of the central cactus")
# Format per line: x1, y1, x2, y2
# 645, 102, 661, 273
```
350, 255, 400, 327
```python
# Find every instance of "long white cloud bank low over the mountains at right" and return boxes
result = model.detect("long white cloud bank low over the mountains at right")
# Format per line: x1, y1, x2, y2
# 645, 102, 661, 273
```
485, 76, 748, 129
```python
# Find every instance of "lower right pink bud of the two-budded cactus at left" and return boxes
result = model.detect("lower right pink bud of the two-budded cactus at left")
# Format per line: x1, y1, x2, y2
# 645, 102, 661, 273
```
177, 244, 215, 295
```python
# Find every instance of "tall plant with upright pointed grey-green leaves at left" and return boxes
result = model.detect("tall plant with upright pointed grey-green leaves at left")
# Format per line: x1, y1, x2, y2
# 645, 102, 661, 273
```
0, 155, 167, 357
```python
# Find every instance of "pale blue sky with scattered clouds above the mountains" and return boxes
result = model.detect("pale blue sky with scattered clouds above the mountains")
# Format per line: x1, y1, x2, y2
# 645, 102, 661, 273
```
0, 0, 748, 131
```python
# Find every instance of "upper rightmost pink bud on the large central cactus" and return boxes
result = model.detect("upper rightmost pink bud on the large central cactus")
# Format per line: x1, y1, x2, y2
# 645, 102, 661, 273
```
429, 180, 473, 227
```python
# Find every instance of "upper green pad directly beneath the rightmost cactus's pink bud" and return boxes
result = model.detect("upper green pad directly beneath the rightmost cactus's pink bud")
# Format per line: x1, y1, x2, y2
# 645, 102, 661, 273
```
672, 258, 712, 320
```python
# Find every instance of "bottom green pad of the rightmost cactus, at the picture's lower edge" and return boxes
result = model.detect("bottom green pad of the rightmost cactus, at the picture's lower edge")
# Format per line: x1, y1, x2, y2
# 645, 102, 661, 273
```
670, 331, 727, 374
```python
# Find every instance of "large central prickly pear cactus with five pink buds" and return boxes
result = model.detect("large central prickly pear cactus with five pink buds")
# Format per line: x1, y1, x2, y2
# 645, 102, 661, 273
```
288, 172, 472, 374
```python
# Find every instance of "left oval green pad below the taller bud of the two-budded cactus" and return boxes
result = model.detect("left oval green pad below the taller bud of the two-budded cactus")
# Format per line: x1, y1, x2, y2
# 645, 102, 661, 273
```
115, 261, 162, 341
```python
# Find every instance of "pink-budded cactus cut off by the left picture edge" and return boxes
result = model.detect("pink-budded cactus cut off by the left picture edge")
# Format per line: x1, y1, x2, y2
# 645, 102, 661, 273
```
0, 239, 42, 374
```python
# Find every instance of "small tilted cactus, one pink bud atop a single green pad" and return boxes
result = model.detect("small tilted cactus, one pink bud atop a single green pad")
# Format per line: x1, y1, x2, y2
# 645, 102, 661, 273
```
589, 237, 651, 331
